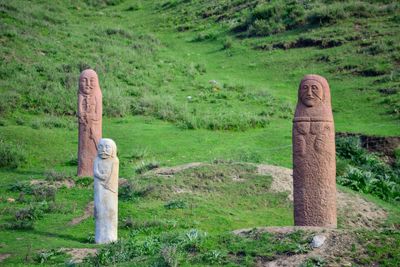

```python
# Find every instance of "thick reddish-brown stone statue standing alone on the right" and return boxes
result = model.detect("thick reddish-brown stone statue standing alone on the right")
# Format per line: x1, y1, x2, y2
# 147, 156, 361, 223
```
293, 75, 337, 227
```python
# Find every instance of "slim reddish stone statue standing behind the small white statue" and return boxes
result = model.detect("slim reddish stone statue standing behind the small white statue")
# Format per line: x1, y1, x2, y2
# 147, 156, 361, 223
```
78, 69, 103, 176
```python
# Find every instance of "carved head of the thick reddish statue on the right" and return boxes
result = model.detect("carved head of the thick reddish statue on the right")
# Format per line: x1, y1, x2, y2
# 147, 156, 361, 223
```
295, 74, 332, 120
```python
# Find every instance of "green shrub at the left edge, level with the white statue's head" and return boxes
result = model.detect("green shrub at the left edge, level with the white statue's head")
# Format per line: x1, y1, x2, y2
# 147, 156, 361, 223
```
0, 139, 26, 169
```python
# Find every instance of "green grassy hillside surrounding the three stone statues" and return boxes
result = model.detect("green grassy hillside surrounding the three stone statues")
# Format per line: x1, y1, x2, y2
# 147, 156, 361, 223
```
0, 0, 400, 266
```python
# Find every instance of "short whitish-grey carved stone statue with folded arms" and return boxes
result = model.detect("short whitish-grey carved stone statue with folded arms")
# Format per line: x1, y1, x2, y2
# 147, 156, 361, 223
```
93, 138, 119, 244
